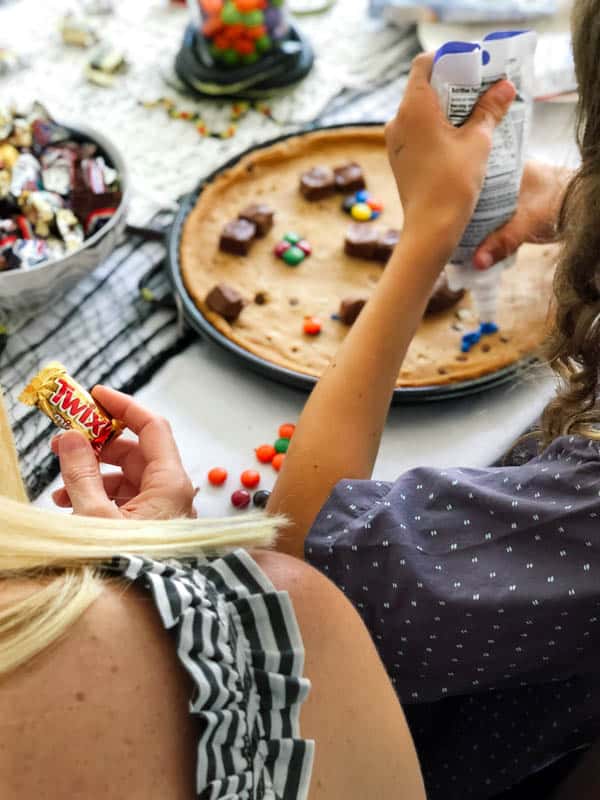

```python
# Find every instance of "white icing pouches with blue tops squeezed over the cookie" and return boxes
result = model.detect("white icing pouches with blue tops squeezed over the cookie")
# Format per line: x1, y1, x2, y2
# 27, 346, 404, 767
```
431, 31, 537, 323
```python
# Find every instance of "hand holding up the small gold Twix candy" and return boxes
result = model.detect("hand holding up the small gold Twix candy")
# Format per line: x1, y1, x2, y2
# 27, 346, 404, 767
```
52, 386, 196, 519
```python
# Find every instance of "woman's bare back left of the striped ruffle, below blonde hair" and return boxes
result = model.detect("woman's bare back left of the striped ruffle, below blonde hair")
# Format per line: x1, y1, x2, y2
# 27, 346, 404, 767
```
0, 581, 197, 800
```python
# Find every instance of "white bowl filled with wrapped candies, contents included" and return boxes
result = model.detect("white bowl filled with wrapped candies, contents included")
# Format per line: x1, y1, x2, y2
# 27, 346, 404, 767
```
0, 103, 129, 311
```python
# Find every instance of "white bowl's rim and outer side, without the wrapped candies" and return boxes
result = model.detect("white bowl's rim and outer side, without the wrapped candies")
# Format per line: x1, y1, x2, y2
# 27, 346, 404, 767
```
0, 123, 130, 311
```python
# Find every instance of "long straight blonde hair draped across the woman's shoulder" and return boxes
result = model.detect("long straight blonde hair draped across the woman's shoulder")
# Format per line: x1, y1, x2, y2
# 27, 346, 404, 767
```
0, 391, 282, 677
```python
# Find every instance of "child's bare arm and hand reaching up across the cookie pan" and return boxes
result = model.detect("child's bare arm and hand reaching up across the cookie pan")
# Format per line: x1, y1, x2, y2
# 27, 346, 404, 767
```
268, 56, 514, 558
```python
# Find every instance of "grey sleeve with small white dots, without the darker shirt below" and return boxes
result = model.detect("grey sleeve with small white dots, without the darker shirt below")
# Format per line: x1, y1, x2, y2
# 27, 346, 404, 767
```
306, 437, 600, 703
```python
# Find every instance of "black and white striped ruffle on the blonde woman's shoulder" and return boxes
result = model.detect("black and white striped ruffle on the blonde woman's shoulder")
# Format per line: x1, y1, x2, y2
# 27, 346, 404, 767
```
105, 550, 314, 800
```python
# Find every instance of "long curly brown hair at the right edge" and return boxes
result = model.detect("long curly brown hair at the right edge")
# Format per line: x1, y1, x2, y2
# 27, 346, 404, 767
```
541, 0, 600, 444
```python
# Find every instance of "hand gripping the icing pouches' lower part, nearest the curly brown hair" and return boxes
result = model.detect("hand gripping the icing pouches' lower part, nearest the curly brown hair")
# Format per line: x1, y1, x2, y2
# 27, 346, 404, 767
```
473, 161, 573, 269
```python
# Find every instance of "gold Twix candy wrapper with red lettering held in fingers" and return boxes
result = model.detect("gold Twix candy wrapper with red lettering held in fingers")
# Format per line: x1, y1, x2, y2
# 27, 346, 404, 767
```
19, 361, 123, 455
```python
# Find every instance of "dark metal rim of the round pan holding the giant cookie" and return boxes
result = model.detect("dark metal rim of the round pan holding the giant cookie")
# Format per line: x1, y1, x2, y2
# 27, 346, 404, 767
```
167, 122, 533, 404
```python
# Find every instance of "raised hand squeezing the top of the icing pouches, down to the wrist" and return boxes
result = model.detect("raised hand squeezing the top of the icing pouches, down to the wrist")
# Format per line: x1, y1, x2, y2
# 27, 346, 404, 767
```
386, 54, 515, 258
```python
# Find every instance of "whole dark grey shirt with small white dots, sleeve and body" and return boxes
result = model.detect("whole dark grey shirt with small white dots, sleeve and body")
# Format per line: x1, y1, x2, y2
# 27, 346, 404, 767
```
306, 437, 600, 800
